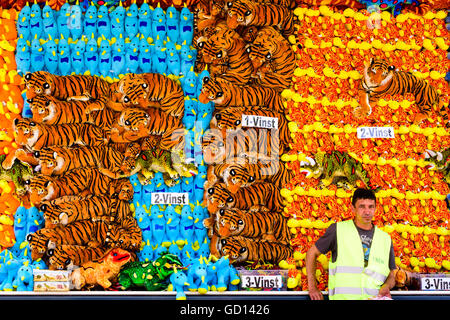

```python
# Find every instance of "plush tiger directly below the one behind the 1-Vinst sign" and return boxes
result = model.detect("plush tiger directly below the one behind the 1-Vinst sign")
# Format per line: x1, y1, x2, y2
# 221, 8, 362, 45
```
201, 128, 285, 164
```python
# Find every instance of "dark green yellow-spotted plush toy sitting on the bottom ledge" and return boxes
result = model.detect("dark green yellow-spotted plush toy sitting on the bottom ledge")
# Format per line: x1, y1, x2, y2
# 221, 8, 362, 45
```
118, 253, 183, 291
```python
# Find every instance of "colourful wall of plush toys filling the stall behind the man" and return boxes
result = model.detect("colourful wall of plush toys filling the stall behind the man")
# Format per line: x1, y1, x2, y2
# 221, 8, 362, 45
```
0, 0, 450, 299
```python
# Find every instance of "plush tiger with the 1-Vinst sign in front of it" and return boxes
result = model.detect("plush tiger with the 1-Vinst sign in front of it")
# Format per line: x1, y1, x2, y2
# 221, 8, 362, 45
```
210, 106, 292, 146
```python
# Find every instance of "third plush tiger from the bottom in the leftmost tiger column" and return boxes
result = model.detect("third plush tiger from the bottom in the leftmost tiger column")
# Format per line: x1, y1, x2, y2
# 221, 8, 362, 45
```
39, 196, 132, 228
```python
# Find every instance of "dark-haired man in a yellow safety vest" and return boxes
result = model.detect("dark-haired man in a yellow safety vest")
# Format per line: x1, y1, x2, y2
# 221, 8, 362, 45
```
306, 189, 396, 300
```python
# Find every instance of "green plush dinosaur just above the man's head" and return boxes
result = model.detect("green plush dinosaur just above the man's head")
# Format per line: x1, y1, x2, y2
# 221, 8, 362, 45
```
300, 151, 372, 189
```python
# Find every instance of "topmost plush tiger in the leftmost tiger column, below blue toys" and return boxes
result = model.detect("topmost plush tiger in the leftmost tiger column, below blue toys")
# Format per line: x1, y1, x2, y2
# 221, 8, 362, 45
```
24, 71, 111, 100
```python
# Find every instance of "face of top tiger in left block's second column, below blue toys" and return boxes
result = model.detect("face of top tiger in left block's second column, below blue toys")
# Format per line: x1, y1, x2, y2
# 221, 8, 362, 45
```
119, 73, 150, 105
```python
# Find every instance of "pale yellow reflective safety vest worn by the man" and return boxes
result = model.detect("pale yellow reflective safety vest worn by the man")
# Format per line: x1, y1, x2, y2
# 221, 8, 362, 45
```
328, 220, 391, 300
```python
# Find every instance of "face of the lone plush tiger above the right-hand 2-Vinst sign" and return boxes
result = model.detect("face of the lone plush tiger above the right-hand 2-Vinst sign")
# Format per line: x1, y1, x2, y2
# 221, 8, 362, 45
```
363, 58, 395, 91
